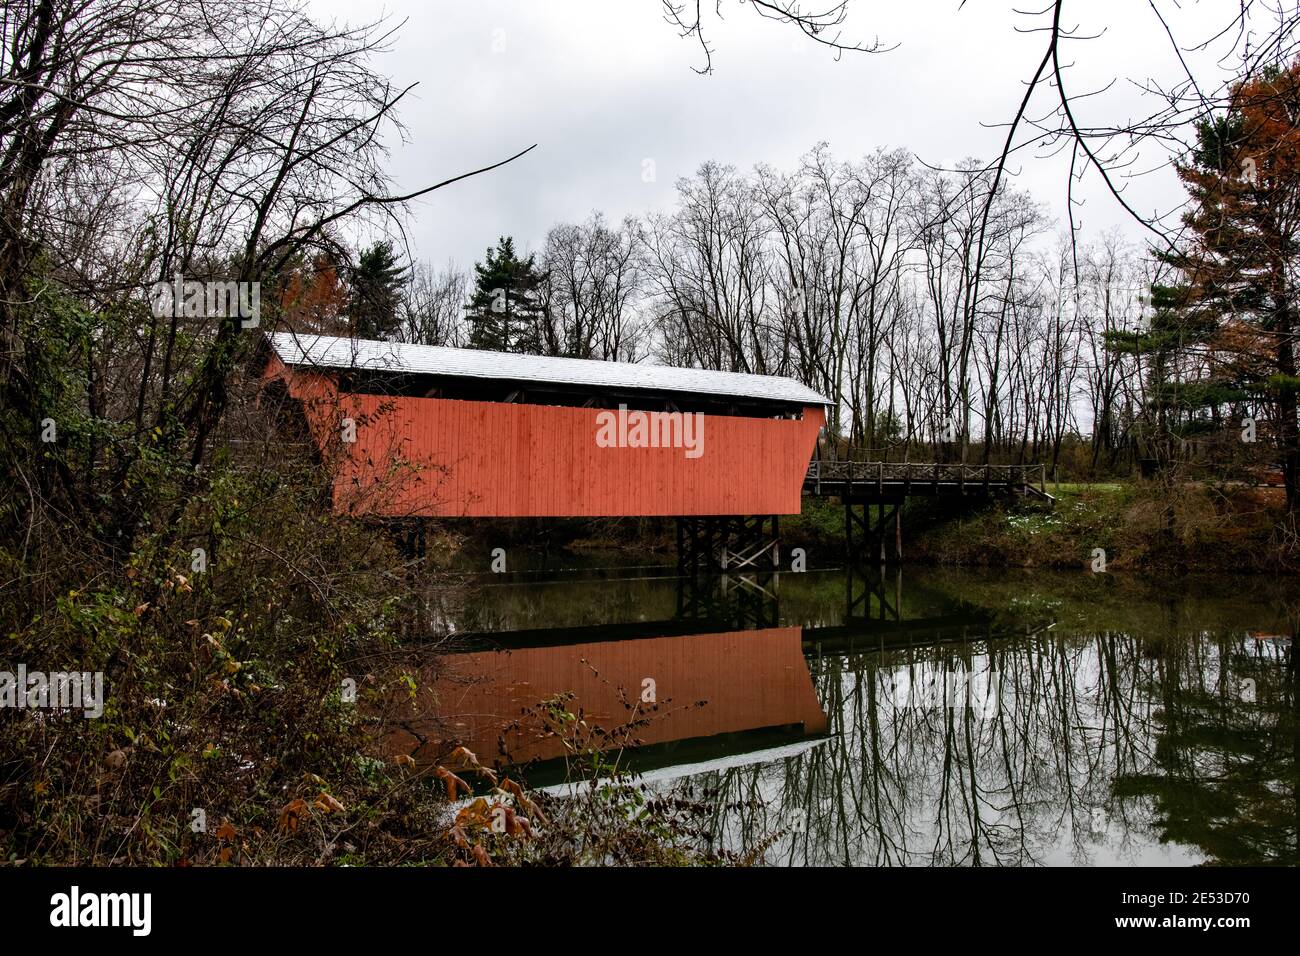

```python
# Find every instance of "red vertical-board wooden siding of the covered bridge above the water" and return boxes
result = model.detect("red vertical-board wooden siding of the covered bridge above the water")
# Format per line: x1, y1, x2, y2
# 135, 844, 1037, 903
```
268, 358, 824, 518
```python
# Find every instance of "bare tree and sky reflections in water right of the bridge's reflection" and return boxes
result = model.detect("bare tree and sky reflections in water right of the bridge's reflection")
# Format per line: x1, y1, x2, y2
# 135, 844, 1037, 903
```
694, 572, 1300, 866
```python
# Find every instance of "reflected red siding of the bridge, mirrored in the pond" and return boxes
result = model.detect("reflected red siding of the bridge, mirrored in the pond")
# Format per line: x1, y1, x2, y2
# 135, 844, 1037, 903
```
386, 627, 827, 765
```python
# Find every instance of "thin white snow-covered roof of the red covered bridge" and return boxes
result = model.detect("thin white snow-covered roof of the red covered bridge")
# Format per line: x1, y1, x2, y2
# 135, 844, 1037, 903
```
269, 332, 831, 405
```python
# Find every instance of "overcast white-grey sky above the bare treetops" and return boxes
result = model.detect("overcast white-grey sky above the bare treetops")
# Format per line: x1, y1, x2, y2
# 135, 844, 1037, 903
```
311, 0, 1258, 267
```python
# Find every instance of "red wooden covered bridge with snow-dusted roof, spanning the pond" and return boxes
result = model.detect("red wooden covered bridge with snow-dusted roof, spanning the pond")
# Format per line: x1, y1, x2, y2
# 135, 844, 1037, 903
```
265, 332, 828, 518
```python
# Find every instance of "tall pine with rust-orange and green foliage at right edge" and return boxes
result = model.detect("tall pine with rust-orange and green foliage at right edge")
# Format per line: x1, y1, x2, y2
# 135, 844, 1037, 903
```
1112, 62, 1300, 511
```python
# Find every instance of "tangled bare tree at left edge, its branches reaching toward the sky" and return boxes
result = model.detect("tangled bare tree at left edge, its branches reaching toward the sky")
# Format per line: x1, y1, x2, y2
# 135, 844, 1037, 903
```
0, 0, 527, 546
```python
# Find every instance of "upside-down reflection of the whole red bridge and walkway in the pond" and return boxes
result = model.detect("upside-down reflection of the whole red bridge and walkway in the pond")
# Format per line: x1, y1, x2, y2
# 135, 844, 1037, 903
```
385, 572, 1050, 786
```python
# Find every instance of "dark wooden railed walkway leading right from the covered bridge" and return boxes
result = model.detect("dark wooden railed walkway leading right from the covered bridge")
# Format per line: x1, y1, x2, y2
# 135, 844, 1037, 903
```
803, 459, 1056, 502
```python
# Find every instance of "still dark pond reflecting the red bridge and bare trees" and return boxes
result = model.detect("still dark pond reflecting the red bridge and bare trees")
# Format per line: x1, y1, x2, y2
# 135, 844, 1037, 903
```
408, 562, 1300, 866
